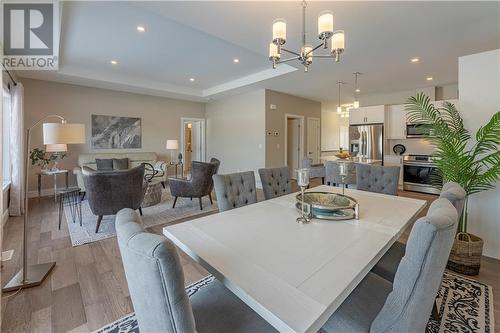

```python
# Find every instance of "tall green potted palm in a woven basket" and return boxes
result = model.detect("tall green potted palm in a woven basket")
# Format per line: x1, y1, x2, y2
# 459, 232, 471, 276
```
406, 93, 500, 275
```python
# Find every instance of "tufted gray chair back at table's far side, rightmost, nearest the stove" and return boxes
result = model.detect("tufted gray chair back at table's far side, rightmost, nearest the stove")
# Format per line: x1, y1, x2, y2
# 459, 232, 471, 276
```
356, 164, 399, 195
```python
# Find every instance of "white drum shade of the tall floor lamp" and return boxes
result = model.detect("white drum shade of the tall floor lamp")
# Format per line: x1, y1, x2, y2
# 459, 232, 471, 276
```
43, 123, 85, 145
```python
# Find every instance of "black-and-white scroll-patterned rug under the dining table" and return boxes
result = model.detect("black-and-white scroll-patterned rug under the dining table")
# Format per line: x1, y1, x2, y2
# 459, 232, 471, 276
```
94, 271, 495, 333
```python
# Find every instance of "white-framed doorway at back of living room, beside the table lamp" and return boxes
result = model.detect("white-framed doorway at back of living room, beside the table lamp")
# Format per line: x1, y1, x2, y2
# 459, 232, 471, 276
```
181, 118, 205, 173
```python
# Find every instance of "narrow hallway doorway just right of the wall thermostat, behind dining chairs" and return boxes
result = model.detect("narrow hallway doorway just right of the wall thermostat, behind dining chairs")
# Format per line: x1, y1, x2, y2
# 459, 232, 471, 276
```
285, 114, 304, 179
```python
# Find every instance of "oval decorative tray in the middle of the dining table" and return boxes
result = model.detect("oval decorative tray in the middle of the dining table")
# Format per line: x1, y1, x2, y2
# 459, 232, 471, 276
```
295, 192, 359, 220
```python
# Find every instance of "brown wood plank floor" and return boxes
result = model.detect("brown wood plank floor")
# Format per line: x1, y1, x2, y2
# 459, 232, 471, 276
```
1, 184, 500, 333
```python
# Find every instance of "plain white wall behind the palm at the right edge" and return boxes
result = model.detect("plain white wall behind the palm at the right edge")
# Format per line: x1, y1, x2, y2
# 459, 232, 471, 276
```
458, 49, 500, 259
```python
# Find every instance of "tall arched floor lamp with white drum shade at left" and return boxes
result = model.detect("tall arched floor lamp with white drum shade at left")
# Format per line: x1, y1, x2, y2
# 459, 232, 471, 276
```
2, 115, 85, 292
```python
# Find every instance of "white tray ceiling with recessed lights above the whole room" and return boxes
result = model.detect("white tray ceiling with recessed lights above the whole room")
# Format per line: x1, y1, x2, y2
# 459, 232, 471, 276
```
18, 1, 500, 101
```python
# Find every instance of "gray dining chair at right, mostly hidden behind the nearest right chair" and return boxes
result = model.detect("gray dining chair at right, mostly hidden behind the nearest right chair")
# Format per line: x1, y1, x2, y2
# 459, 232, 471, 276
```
372, 182, 466, 282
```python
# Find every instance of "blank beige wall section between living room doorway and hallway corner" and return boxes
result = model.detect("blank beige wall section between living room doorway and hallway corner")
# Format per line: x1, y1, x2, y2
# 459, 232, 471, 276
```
206, 89, 265, 176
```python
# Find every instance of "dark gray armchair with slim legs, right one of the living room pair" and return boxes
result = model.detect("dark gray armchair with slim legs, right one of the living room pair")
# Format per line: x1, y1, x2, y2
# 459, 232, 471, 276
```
168, 161, 218, 210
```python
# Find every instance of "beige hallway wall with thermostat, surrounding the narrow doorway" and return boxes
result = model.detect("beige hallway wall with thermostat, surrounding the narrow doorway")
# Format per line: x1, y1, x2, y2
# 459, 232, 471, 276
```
265, 90, 321, 168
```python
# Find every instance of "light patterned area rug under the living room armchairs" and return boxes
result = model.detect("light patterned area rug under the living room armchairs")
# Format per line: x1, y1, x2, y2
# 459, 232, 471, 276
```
64, 188, 217, 246
